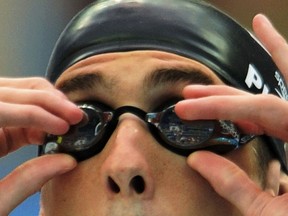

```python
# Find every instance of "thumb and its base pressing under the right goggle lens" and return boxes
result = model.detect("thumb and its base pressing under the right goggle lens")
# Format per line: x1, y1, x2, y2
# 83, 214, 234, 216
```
188, 151, 288, 216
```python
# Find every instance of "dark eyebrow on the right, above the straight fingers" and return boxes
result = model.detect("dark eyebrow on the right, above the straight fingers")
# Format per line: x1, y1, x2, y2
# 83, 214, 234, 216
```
144, 68, 215, 89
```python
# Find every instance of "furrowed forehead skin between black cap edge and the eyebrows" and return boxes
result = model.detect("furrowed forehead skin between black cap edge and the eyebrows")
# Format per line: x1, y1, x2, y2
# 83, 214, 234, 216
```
56, 51, 219, 85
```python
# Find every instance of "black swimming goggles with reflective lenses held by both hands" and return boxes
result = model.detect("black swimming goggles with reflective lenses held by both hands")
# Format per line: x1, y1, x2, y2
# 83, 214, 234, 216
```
39, 103, 255, 161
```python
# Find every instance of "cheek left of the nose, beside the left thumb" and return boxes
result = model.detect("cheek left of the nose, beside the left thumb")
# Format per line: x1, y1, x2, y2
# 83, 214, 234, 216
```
41, 160, 105, 216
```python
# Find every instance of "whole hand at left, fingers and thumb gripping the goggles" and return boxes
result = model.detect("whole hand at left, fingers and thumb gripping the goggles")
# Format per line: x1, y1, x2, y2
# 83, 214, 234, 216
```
0, 78, 83, 215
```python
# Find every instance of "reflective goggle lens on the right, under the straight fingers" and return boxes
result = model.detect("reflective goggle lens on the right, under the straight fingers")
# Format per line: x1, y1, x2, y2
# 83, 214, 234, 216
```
146, 106, 246, 153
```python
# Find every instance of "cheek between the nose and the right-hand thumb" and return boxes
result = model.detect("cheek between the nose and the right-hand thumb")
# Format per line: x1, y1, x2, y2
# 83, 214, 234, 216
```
147, 153, 239, 216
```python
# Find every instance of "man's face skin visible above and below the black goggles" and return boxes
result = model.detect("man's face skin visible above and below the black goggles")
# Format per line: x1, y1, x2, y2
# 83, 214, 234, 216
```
42, 51, 254, 216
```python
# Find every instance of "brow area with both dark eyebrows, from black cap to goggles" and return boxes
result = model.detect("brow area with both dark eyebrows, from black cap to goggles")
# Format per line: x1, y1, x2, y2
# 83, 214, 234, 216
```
56, 51, 222, 108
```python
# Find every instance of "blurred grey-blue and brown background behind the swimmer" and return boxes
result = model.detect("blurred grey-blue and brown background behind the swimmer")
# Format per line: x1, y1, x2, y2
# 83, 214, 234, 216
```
0, 0, 288, 216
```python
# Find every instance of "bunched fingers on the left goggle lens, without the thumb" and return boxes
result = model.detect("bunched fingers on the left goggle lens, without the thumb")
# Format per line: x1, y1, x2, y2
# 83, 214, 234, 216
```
0, 78, 83, 156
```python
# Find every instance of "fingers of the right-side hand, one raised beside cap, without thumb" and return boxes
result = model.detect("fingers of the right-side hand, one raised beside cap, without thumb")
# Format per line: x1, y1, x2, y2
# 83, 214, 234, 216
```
176, 14, 288, 141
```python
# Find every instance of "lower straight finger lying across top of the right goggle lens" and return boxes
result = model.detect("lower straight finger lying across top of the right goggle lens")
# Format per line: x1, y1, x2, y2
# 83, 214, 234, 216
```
175, 94, 288, 140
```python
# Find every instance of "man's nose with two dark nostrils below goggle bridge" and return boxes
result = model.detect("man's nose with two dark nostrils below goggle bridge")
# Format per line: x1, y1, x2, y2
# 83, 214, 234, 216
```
101, 114, 154, 199
